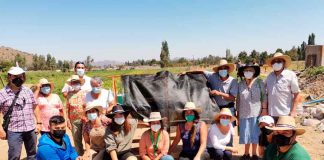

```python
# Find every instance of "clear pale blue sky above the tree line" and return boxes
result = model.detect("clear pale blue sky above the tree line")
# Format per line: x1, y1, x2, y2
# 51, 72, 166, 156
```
0, 0, 324, 62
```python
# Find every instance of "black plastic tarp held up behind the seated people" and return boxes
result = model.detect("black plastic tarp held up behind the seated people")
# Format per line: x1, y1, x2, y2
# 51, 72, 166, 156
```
122, 71, 219, 121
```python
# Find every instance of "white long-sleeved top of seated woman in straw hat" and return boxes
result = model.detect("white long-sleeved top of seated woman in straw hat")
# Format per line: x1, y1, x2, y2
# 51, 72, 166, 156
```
207, 124, 234, 151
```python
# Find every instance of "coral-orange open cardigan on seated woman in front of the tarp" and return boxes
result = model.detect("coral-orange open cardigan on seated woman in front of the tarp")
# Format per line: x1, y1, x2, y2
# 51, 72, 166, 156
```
139, 129, 170, 159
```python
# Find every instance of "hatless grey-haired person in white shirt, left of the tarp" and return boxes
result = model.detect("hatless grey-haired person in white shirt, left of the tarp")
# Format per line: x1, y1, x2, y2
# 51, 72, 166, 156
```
85, 77, 115, 114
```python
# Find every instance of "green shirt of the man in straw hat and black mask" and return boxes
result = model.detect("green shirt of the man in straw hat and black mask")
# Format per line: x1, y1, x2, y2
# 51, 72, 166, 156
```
264, 143, 311, 160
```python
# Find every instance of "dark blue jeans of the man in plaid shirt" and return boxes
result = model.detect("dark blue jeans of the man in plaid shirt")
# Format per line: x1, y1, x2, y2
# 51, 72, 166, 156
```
7, 130, 37, 160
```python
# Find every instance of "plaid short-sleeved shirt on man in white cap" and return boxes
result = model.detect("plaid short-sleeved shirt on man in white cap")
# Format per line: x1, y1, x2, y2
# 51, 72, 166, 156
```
0, 86, 37, 132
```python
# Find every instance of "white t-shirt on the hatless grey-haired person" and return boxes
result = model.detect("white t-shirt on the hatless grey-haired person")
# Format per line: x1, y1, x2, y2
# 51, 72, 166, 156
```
85, 88, 114, 108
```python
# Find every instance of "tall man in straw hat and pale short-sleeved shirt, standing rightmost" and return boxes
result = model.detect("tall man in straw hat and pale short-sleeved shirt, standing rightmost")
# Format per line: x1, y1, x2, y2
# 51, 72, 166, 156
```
265, 53, 300, 121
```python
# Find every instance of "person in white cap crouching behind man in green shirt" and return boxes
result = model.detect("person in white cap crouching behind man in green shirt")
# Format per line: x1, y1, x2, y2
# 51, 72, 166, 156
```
259, 116, 274, 156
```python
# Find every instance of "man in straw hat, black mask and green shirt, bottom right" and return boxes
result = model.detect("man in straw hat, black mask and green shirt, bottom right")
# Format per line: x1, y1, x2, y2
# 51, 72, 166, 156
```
264, 116, 311, 160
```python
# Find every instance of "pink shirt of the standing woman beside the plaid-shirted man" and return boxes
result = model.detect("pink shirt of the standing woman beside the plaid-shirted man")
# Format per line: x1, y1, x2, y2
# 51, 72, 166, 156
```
37, 94, 63, 132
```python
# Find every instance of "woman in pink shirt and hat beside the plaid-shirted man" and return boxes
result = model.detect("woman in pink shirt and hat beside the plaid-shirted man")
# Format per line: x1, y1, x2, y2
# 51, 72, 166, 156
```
35, 78, 64, 134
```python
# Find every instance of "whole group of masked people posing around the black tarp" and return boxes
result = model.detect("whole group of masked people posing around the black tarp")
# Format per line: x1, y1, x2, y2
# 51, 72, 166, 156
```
0, 53, 310, 160
